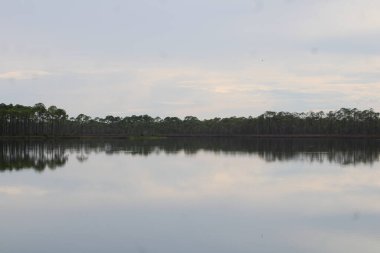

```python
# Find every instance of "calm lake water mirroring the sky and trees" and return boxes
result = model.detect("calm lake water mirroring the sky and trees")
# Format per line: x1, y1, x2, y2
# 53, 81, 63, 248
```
0, 139, 380, 253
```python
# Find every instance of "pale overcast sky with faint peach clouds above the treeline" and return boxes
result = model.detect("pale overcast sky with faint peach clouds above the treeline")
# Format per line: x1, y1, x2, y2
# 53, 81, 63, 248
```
0, 0, 380, 118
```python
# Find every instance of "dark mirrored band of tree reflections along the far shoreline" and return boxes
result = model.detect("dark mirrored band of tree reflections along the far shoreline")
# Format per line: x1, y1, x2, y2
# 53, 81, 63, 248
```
0, 138, 380, 171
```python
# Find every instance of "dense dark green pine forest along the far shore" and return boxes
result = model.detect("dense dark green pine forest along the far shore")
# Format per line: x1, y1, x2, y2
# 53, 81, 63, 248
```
0, 103, 380, 137
